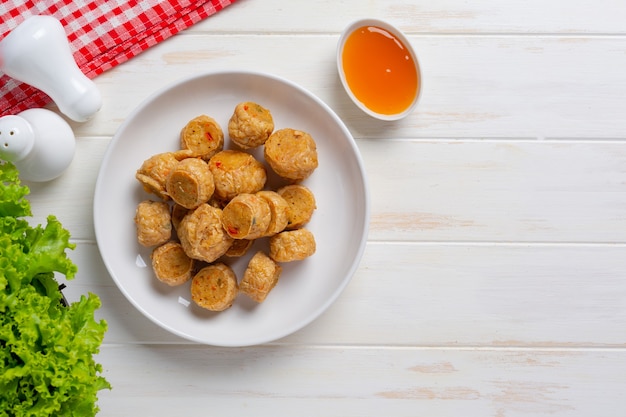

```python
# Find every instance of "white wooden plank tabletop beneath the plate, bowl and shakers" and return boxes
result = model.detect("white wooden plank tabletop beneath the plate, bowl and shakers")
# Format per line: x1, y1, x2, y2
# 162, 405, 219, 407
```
30, 0, 626, 417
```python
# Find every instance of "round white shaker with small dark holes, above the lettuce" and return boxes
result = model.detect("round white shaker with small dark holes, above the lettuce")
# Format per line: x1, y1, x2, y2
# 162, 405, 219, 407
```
0, 109, 76, 182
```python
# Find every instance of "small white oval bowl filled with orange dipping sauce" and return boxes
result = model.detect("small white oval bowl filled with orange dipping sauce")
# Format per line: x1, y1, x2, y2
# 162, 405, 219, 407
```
337, 19, 422, 120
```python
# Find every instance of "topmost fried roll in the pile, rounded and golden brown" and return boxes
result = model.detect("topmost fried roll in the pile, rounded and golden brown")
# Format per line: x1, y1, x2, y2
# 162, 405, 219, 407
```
228, 101, 274, 149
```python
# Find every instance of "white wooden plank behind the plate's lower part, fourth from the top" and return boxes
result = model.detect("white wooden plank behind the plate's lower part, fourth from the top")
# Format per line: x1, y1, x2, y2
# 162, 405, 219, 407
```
65, 242, 626, 347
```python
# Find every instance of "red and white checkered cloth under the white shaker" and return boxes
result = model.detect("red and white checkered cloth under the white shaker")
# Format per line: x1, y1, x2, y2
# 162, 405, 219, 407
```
0, 0, 235, 116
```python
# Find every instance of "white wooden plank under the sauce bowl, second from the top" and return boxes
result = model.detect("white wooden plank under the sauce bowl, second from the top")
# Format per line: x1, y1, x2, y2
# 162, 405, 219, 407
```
67, 35, 626, 139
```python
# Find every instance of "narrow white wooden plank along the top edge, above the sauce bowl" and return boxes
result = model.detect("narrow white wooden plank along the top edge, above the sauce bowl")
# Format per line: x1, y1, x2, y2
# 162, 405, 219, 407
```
196, 0, 626, 34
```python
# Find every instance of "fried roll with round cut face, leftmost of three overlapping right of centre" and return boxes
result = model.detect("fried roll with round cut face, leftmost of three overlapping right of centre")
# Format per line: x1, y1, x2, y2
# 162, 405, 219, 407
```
222, 193, 272, 239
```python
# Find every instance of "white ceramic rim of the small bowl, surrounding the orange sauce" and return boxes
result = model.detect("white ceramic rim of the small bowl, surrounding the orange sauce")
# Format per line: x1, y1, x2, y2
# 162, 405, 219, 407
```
337, 19, 422, 121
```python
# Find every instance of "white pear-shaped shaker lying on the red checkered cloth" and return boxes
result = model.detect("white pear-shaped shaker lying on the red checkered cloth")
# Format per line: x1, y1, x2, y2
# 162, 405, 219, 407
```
0, 15, 102, 122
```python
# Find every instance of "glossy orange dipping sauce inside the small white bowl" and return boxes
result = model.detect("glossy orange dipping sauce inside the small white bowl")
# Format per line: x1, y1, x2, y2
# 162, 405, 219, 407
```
341, 26, 420, 115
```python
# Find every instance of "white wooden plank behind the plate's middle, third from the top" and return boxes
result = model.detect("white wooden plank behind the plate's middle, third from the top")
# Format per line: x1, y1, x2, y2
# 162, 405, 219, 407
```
23, 138, 626, 243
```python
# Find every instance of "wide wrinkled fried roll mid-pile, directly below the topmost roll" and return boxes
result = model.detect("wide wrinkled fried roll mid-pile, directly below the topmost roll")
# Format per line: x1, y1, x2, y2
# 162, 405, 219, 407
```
209, 150, 267, 201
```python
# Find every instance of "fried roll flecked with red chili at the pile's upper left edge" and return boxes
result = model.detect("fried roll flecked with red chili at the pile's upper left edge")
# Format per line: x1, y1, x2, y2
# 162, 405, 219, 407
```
180, 114, 224, 161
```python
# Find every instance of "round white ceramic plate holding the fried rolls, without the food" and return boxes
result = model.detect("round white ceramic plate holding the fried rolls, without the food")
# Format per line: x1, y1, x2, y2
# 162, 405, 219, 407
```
94, 72, 369, 346
